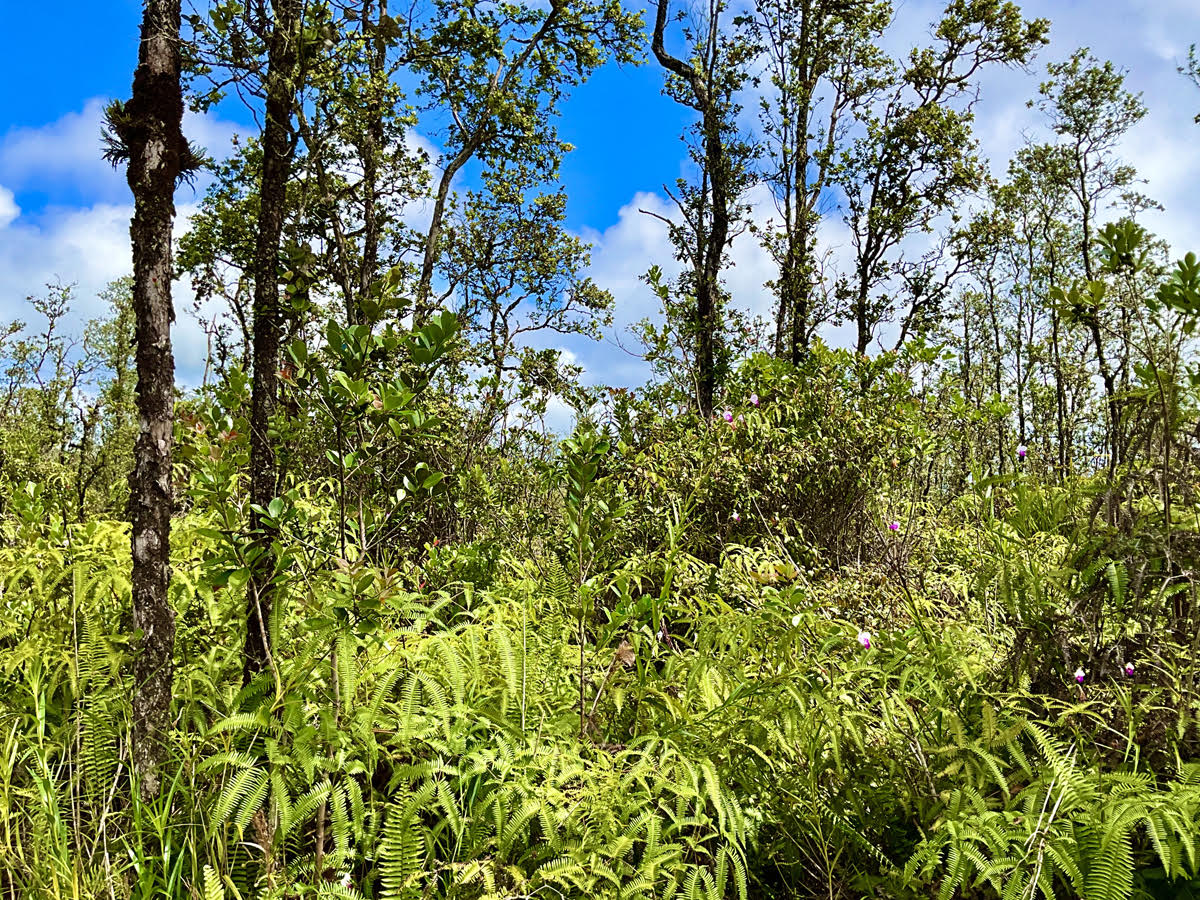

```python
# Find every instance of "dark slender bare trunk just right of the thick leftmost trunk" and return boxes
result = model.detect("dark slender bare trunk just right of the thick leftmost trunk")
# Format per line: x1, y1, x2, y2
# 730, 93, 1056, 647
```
242, 0, 301, 682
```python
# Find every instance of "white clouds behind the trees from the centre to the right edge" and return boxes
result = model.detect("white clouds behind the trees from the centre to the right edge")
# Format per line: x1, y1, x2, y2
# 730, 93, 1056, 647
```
571, 0, 1200, 385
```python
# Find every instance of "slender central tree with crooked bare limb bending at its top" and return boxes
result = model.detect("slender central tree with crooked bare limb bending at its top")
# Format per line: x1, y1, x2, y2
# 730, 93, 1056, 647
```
653, 0, 754, 416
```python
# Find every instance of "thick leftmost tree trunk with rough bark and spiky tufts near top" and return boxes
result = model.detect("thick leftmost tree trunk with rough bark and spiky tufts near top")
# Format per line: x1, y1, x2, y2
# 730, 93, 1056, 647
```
106, 0, 198, 798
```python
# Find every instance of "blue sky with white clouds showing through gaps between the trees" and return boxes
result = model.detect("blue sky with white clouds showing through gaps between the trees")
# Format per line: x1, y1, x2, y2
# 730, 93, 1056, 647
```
0, 0, 1200, 400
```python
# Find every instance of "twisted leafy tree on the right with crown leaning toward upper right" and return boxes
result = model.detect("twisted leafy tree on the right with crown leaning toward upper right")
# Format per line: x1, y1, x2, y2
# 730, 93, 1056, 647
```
839, 0, 1049, 353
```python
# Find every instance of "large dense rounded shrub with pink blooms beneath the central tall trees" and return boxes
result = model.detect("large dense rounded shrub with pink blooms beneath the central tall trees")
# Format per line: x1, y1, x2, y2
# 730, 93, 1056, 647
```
617, 342, 919, 565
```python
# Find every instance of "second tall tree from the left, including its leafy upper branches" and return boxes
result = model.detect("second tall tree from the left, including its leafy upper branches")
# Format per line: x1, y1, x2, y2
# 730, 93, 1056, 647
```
185, 0, 312, 680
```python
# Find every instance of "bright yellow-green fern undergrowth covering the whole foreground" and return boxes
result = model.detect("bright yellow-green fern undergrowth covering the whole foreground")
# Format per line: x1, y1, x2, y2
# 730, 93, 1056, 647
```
0, 403, 1200, 898
